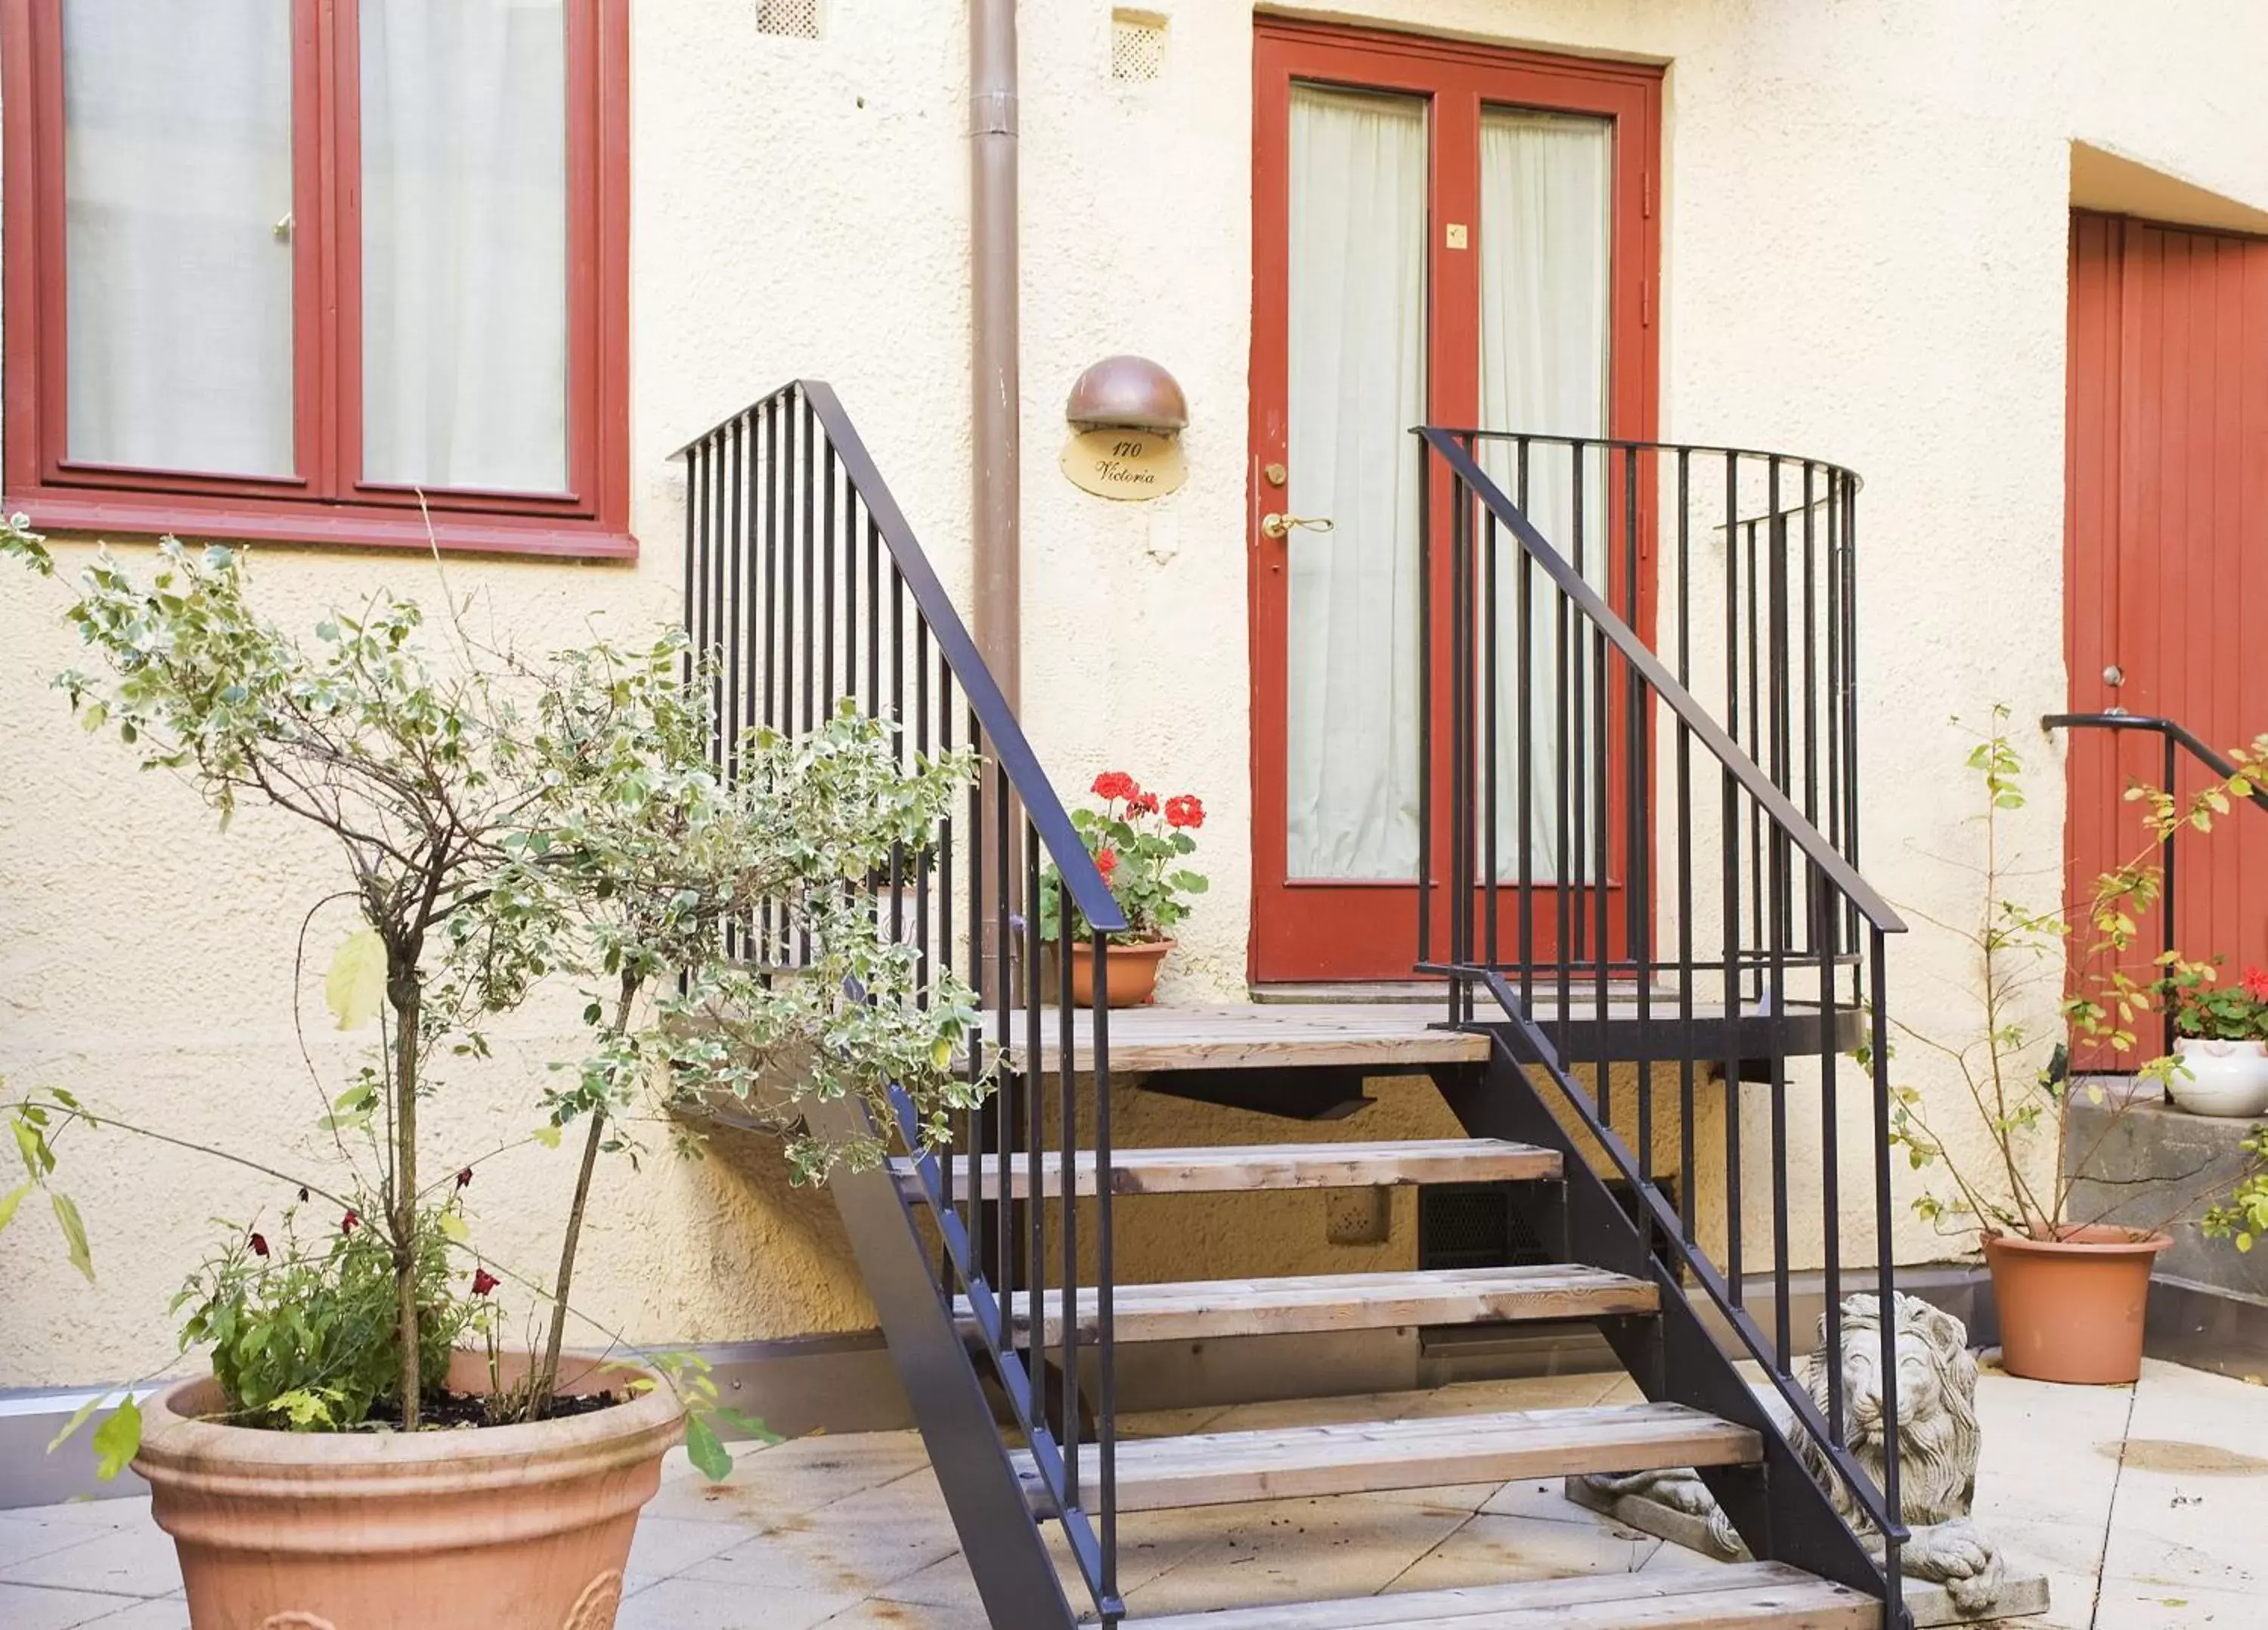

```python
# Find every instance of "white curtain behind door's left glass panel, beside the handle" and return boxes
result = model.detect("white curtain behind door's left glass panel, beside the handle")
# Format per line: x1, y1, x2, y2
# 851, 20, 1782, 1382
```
1279, 86, 1427, 879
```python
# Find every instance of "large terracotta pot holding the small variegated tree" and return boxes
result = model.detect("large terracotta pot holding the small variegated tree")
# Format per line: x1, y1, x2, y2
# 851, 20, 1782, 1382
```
134, 1353, 683, 1630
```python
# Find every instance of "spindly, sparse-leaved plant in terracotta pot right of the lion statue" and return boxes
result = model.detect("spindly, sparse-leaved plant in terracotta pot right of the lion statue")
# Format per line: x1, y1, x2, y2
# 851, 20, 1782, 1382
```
1862, 708, 2268, 1383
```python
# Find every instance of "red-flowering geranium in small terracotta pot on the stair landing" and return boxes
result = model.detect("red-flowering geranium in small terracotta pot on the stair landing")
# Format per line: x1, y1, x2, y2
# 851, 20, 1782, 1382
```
1039, 771, 1207, 1006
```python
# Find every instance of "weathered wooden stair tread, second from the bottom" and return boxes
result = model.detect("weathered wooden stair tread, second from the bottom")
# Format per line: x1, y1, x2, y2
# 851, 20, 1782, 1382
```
1016, 1403, 1765, 1514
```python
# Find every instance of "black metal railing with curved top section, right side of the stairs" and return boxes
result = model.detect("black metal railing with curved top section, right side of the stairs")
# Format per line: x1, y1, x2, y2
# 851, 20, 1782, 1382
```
1418, 426, 1905, 1623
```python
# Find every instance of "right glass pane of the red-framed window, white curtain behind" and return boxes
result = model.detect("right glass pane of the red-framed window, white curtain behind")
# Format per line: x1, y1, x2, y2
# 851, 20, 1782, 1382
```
361, 0, 567, 492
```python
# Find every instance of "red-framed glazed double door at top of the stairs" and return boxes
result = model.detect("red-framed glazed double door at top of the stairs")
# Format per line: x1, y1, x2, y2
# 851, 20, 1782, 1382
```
1250, 20, 1660, 981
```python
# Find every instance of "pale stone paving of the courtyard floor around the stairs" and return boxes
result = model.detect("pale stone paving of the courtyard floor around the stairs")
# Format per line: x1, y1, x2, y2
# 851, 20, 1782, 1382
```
0, 1362, 2268, 1630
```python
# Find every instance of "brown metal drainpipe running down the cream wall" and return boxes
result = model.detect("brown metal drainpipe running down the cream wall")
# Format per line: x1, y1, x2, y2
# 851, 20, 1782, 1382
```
968, 0, 1023, 708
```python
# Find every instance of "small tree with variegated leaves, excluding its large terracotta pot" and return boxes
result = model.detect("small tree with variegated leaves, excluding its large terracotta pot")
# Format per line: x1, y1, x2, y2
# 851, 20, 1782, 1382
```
0, 517, 987, 1428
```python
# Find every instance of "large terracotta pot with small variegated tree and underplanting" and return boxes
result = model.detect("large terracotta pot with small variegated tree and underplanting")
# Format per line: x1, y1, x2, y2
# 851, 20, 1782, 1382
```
0, 519, 984, 1630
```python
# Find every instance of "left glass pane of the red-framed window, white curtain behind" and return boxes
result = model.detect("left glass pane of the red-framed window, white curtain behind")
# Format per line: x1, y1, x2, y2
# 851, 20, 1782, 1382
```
64, 0, 293, 476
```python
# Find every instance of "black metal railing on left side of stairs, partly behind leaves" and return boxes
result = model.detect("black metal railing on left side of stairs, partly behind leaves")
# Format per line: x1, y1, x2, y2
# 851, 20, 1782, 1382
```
683, 381, 1125, 1623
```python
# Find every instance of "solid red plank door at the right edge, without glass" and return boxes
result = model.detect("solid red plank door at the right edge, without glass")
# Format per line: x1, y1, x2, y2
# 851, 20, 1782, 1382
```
2064, 213, 2268, 1052
